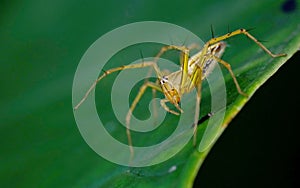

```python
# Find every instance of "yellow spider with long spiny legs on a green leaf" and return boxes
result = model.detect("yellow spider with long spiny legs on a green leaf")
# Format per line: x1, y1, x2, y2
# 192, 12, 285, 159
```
74, 29, 286, 156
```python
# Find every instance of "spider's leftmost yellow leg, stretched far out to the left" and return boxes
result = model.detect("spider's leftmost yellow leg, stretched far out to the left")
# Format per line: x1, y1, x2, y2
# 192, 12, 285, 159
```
74, 61, 161, 110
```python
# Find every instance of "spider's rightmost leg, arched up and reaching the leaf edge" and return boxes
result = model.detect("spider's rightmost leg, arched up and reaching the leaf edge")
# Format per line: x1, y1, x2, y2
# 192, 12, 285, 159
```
206, 29, 286, 57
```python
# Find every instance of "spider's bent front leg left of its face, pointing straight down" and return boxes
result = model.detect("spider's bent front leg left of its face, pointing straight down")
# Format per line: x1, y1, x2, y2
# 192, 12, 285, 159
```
126, 81, 162, 159
